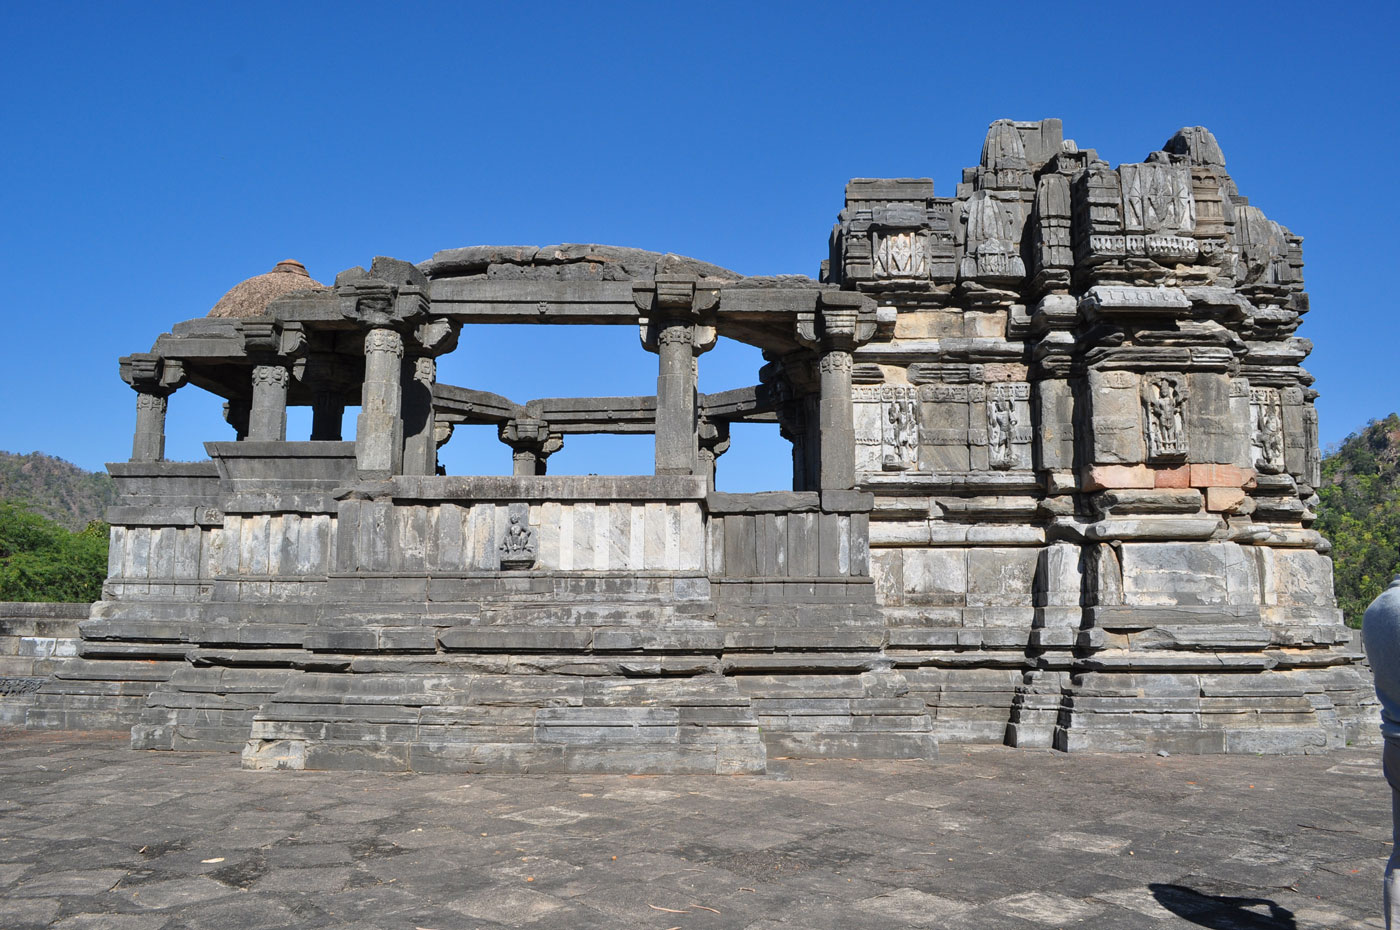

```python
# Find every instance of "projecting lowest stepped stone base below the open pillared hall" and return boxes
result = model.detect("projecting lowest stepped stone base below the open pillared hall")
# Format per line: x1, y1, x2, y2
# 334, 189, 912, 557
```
242, 671, 767, 775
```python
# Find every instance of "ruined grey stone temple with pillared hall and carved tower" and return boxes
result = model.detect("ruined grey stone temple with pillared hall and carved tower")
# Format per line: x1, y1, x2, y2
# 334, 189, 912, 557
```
27, 119, 1375, 773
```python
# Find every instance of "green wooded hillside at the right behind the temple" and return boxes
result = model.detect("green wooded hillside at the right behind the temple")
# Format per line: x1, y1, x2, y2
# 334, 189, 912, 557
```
1313, 413, 1400, 626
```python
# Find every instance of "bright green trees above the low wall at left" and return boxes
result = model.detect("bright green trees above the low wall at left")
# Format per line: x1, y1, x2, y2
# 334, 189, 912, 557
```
0, 500, 108, 602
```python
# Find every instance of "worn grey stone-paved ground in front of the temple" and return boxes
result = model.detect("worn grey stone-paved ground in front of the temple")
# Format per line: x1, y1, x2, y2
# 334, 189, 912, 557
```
0, 731, 1389, 930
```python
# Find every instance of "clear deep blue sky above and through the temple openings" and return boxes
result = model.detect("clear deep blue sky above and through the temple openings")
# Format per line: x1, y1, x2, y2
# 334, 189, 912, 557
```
0, 1, 1400, 490
